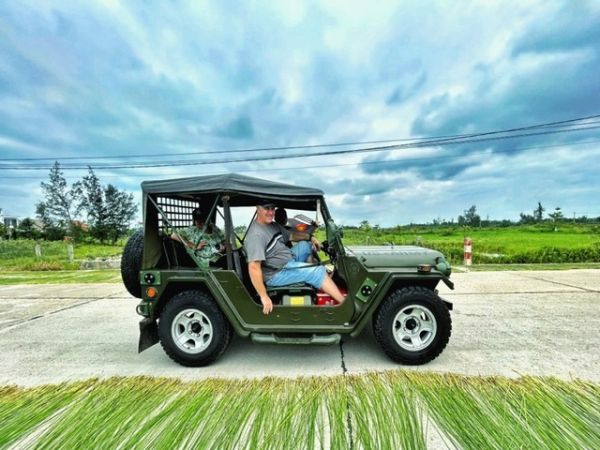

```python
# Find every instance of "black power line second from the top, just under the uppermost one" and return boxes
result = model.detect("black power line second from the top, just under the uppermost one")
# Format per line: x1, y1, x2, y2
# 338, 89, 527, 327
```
0, 124, 600, 170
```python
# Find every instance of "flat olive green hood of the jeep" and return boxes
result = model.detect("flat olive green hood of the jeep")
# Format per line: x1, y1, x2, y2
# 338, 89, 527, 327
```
346, 245, 449, 267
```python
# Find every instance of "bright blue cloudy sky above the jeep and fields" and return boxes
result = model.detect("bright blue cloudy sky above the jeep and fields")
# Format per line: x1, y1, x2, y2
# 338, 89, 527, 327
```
0, 0, 600, 226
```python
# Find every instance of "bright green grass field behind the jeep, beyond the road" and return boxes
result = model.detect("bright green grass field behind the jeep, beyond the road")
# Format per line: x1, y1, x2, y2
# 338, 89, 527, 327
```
0, 224, 600, 278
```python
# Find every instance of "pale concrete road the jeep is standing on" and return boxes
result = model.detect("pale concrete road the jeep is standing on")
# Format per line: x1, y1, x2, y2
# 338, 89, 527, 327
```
0, 270, 600, 386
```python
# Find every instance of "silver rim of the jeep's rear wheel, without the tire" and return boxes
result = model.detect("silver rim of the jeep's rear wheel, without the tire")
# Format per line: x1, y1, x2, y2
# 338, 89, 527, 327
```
171, 308, 213, 354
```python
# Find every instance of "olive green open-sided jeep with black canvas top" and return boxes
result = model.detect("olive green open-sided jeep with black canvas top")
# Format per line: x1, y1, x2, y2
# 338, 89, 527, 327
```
121, 174, 453, 366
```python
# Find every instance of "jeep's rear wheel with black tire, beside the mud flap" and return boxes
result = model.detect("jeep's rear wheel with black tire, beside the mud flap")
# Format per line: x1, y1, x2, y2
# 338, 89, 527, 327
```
158, 290, 233, 367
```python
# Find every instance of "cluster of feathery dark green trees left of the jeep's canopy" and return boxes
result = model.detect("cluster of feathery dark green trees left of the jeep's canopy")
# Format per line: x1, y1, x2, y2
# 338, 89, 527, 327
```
0, 162, 138, 244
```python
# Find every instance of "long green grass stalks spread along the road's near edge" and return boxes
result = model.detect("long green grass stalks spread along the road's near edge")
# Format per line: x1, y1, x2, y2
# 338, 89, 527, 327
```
0, 371, 600, 450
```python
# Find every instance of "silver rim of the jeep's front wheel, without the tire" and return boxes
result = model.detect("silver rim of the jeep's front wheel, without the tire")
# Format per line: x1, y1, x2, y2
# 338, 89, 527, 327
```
392, 305, 437, 352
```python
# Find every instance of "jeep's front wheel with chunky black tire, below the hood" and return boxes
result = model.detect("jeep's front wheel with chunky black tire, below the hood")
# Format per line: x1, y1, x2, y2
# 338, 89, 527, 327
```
373, 286, 452, 365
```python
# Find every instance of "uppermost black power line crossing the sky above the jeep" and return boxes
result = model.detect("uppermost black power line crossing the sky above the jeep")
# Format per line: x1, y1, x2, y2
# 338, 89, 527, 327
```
0, 114, 600, 163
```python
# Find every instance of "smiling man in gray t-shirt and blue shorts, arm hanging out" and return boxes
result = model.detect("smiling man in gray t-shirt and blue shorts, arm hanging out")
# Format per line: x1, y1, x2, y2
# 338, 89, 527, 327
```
244, 200, 345, 314
